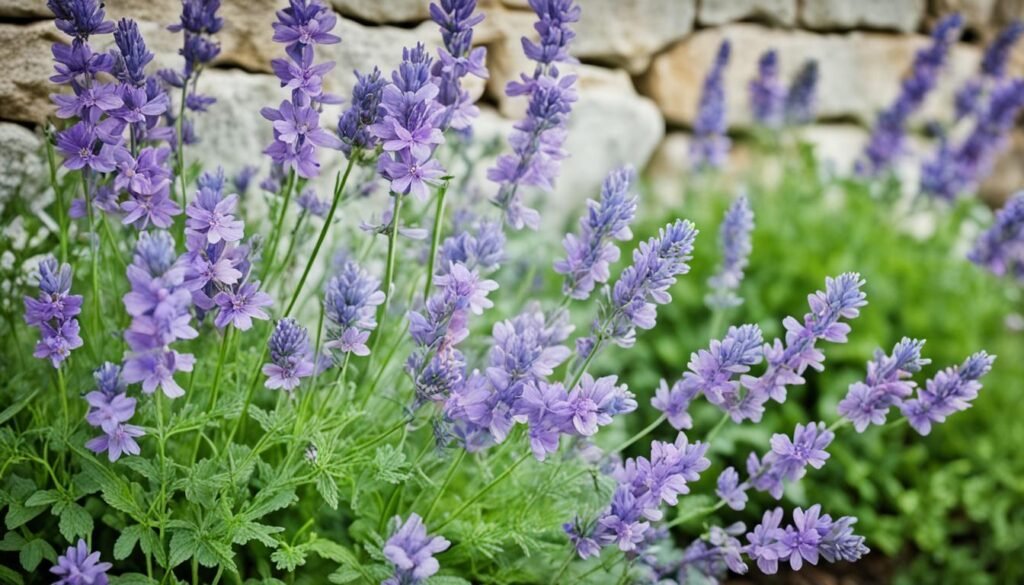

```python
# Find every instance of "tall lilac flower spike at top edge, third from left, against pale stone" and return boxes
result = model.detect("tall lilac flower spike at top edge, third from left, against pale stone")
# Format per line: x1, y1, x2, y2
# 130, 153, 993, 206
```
260, 0, 341, 178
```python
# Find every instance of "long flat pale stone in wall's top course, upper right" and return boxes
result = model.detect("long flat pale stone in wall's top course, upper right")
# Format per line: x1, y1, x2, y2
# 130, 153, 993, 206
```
800, 0, 925, 33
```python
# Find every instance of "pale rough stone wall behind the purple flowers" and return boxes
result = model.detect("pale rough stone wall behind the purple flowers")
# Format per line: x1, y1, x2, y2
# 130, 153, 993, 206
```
0, 0, 1024, 213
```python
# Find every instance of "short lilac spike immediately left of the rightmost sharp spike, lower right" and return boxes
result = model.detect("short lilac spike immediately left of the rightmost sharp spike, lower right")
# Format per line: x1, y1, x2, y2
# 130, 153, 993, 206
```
839, 337, 931, 432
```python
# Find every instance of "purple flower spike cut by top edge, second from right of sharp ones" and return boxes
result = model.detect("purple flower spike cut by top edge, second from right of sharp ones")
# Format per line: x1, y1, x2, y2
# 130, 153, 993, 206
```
430, 0, 487, 130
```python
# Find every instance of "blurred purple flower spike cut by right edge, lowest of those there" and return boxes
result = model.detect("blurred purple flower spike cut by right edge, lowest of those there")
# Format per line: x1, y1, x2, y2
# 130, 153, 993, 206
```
968, 193, 1024, 280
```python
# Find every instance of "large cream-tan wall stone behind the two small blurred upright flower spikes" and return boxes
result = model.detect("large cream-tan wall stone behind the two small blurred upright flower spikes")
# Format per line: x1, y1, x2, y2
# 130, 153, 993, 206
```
641, 25, 979, 128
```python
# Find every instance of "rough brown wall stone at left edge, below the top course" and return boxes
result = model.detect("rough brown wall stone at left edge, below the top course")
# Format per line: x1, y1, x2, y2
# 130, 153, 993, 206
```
0, 22, 60, 124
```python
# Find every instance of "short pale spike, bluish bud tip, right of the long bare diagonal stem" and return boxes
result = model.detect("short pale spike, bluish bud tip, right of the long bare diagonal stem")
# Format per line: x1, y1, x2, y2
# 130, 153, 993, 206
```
324, 261, 384, 356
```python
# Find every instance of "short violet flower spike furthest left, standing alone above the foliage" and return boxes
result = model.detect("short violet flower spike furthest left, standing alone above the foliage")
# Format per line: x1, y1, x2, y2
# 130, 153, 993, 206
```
24, 256, 82, 368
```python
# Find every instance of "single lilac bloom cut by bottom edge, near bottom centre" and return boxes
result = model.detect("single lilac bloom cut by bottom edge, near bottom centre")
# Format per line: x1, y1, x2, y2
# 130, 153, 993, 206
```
383, 512, 452, 585
